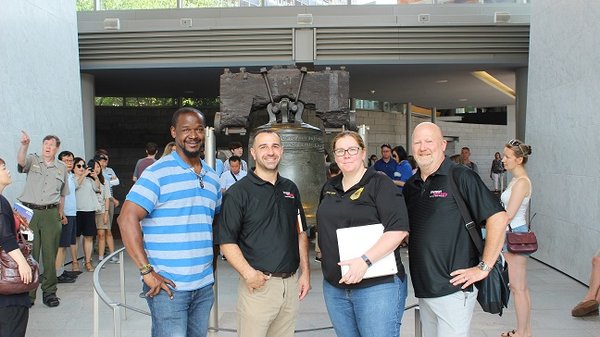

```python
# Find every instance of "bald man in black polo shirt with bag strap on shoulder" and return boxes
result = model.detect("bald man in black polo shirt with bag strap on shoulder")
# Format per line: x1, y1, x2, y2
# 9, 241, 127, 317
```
403, 122, 508, 337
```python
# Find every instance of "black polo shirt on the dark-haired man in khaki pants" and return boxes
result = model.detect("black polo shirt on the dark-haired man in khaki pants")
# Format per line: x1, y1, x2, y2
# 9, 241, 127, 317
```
216, 171, 307, 273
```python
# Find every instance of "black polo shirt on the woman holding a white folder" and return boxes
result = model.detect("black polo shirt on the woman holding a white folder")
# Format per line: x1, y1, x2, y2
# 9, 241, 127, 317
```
317, 167, 408, 289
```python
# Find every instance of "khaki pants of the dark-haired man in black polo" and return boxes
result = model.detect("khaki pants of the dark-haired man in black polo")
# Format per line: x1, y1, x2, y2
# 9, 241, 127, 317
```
237, 274, 299, 337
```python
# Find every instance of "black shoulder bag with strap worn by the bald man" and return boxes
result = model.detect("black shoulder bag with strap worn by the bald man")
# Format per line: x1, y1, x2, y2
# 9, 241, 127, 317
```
449, 166, 510, 316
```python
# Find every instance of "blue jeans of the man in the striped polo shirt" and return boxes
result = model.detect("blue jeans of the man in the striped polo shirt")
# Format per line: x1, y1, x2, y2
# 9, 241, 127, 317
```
144, 284, 215, 337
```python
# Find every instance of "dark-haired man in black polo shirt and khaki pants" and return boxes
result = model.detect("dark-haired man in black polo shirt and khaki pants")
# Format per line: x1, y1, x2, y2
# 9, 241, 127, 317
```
217, 130, 310, 337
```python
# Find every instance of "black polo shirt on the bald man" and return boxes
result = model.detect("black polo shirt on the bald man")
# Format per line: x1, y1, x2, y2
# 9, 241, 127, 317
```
403, 158, 504, 298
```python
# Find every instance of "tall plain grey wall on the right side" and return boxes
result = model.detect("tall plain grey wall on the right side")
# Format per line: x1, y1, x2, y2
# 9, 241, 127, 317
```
526, 0, 600, 283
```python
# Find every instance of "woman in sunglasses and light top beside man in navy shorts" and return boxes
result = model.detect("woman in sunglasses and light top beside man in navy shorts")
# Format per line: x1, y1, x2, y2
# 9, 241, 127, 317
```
73, 157, 102, 271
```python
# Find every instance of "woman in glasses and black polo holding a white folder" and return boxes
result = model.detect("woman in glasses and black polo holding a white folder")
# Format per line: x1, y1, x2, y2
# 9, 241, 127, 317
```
317, 131, 408, 337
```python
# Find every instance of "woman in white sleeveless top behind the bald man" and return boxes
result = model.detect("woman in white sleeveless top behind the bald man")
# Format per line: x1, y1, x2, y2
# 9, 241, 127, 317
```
500, 139, 532, 337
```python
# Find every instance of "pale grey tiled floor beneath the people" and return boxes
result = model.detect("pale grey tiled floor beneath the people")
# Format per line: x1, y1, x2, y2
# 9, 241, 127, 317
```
27, 244, 600, 337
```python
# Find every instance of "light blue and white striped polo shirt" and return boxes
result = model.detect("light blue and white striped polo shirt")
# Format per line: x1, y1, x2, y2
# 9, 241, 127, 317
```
126, 152, 221, 291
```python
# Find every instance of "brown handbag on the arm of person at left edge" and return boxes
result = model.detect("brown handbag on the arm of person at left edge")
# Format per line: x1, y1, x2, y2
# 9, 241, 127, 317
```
0, 213, 40, 295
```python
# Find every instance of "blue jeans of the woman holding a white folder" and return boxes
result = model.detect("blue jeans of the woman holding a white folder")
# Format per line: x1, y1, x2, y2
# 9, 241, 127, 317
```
323, 276, 406, 337
